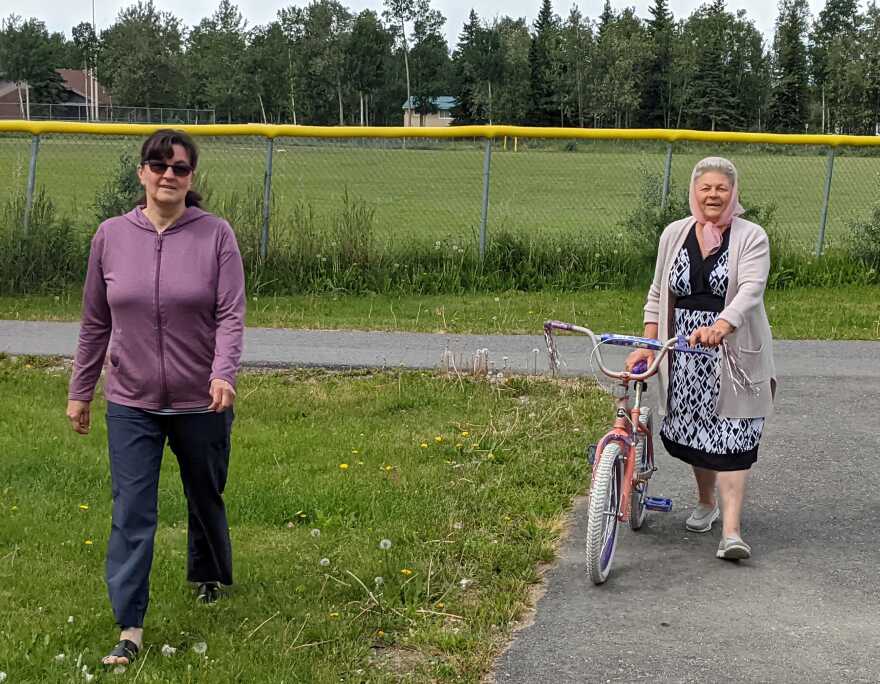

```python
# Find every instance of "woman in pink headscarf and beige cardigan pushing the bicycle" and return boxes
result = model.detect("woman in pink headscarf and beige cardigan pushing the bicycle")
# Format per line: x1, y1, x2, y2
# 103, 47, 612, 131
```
627, 157, 776, 560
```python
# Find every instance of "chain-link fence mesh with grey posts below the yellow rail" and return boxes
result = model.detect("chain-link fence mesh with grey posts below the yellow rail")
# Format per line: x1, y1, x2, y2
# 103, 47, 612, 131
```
0, 123, 880, 292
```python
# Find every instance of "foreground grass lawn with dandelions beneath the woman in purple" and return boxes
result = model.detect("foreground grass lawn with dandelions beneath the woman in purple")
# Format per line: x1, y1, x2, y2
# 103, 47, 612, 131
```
0, 357, 610, 684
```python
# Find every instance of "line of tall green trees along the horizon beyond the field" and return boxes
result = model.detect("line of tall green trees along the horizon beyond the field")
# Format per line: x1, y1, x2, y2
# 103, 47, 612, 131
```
0, 0, 880, 134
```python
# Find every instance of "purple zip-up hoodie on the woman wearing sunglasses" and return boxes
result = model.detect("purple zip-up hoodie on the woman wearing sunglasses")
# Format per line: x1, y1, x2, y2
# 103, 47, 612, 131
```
68, 207, 245, 409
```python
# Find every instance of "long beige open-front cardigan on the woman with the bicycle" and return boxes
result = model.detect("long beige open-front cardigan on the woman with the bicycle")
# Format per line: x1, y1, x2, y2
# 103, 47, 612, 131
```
645, 216, 776, 418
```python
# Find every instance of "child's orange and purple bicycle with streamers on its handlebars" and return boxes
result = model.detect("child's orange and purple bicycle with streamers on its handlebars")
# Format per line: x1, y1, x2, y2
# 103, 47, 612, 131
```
544, 321, 710, 584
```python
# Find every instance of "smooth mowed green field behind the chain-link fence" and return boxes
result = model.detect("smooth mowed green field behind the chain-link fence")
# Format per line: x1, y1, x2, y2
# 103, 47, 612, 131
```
0, 135, 880, 248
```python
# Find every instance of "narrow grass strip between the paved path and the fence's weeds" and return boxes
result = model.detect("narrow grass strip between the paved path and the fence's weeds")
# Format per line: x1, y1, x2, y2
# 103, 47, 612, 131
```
0, 286, 880, 340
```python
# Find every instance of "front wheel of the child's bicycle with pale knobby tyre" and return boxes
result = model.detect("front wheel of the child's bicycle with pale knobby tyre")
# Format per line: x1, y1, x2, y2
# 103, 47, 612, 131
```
586, 443, 623, 584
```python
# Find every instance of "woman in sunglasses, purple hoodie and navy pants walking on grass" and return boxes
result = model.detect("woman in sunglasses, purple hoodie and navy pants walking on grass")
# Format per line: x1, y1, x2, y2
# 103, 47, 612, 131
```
67, 130, 245, 665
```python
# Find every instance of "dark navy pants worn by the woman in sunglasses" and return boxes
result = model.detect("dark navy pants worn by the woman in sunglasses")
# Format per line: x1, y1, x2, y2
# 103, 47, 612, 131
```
107, 402, 233, 628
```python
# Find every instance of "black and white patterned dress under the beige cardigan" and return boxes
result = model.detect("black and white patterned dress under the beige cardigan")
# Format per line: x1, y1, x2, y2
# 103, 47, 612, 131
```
660, 225, 764, 470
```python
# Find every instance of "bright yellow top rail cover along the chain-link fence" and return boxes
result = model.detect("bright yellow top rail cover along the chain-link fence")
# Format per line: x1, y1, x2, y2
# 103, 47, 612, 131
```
0, 120, 880, 147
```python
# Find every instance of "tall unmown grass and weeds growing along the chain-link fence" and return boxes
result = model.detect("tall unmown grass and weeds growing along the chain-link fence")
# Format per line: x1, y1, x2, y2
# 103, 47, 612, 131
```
0, 159, 880, 295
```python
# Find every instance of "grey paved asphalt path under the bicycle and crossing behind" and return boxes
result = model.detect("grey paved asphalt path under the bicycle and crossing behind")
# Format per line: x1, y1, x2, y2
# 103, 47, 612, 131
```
0, 321, 880, 684
